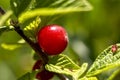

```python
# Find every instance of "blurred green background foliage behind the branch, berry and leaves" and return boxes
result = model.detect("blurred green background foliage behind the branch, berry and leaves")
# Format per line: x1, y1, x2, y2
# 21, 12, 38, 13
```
0, 0, 120, 80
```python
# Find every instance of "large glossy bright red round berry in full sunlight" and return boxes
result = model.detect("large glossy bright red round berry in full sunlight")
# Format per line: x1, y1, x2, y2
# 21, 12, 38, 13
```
38, 24, 68, 55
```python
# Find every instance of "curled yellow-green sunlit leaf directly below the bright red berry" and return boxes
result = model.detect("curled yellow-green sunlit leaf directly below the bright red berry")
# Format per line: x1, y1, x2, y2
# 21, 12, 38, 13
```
45, 54, 87, 80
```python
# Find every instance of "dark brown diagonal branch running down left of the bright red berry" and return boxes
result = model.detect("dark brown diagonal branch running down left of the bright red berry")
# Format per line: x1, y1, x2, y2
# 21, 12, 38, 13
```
11, 20, 48, 65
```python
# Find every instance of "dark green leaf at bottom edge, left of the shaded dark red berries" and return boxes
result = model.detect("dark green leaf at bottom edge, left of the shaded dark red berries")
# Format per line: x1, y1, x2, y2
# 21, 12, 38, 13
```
17, 71, 37, 80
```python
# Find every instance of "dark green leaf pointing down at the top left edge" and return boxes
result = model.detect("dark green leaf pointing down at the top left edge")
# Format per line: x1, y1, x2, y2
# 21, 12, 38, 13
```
10, 0, 32, 16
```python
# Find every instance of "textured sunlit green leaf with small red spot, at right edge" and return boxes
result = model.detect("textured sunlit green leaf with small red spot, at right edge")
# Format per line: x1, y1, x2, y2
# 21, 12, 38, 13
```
87, 44, 120, 76
